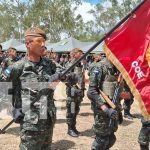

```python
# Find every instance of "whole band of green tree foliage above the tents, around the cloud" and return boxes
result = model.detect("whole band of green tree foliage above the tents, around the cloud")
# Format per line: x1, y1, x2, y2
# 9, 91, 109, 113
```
0, 0, 141, 42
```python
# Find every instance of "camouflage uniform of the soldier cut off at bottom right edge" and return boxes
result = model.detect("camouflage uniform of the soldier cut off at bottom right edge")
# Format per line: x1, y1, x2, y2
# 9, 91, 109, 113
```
138, 118, 150, 150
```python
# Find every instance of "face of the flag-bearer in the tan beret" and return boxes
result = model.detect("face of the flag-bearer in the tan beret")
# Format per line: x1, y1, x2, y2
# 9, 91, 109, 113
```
26, 37, 45, 57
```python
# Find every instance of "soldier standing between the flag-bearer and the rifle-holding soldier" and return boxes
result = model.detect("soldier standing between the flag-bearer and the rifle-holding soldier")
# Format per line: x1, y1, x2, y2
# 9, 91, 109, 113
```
65, 48, 85, 137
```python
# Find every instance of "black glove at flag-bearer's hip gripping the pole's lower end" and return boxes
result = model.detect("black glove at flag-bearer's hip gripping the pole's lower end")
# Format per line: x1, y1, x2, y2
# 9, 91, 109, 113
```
12, 108, 24, 123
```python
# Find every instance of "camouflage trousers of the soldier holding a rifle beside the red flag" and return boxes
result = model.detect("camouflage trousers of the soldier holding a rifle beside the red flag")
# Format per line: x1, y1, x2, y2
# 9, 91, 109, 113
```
91, 102, 118, 150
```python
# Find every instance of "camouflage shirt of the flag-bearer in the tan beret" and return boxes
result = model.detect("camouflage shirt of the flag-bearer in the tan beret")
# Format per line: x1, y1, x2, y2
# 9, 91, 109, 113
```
0, 58, 57, 131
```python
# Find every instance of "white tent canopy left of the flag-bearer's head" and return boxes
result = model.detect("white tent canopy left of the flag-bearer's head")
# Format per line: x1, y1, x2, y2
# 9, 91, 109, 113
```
1, 39, 22, 50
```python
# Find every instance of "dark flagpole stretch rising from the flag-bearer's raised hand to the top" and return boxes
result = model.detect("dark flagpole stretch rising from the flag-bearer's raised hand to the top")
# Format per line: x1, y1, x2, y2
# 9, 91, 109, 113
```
62, 0, 146, 76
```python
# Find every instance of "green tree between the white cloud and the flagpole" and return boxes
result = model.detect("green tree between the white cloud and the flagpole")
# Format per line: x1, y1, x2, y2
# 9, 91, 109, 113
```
89, 0, 142, 33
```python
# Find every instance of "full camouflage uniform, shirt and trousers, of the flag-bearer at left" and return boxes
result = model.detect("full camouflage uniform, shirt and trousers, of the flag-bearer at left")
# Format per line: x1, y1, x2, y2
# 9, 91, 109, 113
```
1, 58, 60, 150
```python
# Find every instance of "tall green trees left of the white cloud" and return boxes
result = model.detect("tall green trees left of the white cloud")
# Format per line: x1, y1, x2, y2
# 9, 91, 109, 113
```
0, 0, 84, 42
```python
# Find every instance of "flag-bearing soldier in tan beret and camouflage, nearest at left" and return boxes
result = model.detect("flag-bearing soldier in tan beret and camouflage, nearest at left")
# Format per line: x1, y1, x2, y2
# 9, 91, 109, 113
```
0, 27, 62, 150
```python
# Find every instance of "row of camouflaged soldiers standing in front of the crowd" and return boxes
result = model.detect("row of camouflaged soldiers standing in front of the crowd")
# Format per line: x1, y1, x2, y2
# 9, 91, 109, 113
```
0, 27, 150, 150
